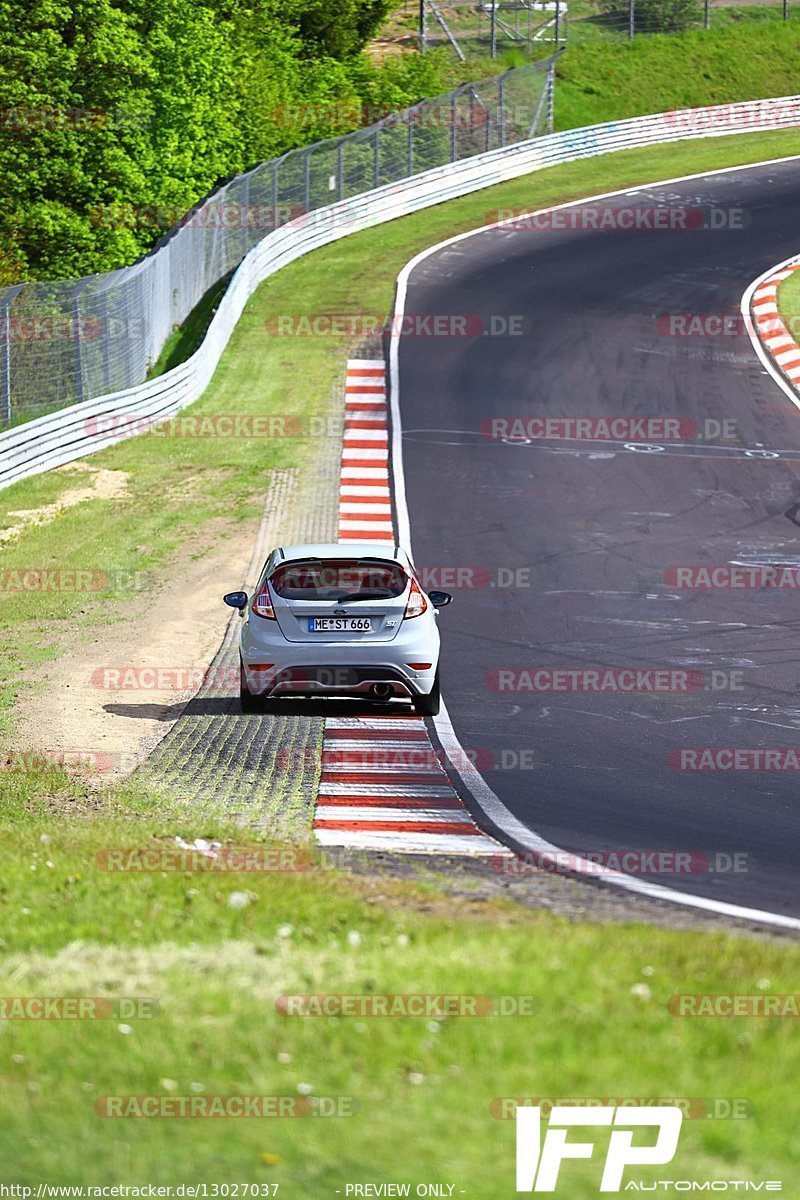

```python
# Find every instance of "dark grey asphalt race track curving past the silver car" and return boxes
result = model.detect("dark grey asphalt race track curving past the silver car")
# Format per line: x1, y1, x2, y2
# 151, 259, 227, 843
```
399, 162, 800, 916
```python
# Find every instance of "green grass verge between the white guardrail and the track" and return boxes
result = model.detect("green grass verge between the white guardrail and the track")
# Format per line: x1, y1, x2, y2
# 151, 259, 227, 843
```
0, 131, 800, 734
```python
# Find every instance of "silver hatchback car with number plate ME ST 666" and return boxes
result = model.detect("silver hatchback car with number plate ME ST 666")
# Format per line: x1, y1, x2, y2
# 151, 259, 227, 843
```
224, 541, 452, 716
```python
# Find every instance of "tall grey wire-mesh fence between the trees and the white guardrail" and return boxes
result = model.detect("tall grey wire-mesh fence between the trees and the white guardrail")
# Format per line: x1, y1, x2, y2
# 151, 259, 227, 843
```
0, 59, 554, 428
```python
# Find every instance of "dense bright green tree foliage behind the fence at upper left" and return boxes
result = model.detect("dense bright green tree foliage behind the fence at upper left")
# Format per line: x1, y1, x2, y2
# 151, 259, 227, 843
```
0, 0, 438, 280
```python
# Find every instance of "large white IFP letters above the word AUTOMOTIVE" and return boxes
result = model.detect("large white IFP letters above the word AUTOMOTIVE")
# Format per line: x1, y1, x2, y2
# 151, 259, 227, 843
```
517, 1104, 684, 1192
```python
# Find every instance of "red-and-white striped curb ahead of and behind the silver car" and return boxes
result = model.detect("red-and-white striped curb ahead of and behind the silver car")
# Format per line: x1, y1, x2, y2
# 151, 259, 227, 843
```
314, 359, 509, 854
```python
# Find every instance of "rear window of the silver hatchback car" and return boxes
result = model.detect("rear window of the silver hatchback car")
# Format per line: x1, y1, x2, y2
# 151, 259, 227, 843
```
270, 558, 408, 600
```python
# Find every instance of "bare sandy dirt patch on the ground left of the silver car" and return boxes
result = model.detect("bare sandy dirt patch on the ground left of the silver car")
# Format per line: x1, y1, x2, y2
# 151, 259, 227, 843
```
12, 516, 259, 786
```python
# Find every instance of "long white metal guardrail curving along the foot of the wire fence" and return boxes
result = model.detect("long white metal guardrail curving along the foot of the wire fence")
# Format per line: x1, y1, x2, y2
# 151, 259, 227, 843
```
0, 96, 800, 487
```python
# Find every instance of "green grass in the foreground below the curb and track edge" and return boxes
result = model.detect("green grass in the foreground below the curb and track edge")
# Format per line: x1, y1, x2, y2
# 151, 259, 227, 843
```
0, 781, 800, 1185
